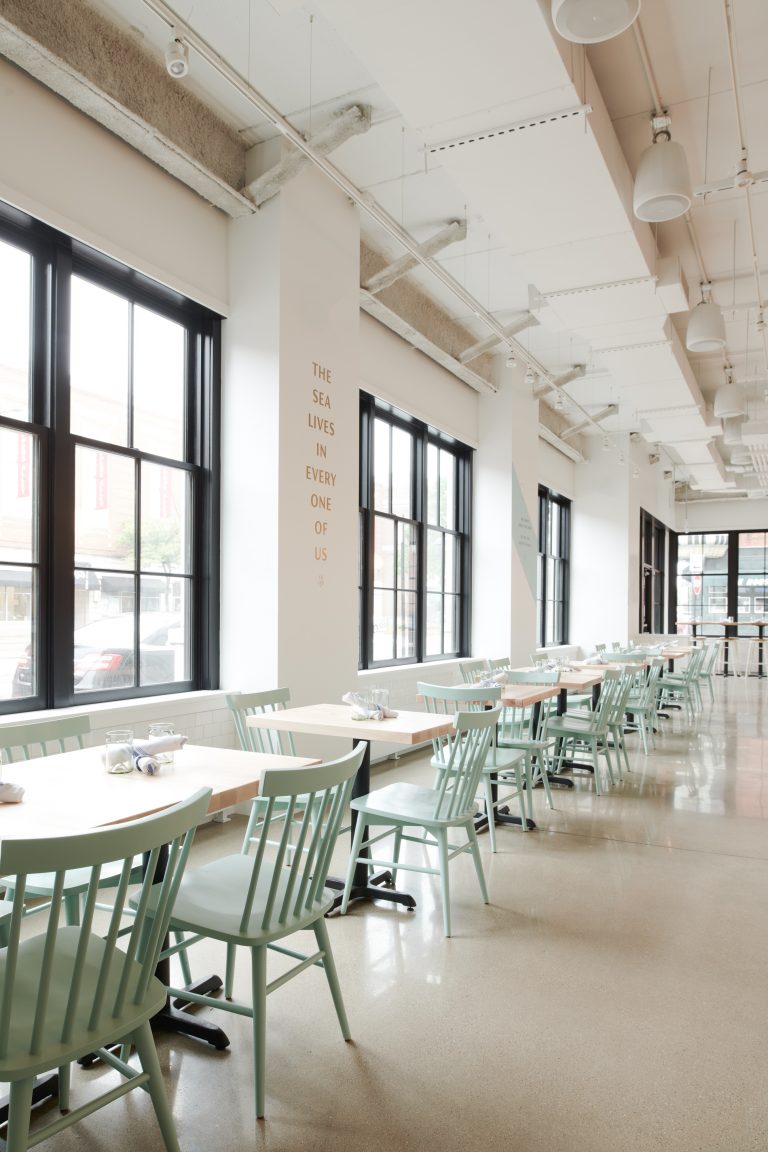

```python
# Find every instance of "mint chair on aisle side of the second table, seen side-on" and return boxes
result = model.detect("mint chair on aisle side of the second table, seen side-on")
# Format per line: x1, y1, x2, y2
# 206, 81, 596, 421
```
341, 707, 500, 937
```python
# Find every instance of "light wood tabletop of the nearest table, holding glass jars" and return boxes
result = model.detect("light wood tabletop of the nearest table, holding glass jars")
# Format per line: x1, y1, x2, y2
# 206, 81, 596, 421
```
0, 744, 318, 839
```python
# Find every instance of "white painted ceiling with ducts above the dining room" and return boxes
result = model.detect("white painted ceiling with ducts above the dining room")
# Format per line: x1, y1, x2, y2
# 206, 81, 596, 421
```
69, 0, 768, 498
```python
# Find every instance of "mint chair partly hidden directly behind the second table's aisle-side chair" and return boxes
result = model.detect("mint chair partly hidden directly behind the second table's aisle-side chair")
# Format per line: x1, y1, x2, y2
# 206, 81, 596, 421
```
416, 683, 532, 852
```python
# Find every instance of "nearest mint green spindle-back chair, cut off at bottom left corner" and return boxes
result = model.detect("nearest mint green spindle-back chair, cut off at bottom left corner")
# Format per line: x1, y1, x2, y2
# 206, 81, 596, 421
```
0, 788, 211, 1152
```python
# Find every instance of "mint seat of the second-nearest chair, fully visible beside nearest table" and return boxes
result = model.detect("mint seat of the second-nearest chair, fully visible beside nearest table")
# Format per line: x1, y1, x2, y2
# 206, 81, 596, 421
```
165, 852, 336, 947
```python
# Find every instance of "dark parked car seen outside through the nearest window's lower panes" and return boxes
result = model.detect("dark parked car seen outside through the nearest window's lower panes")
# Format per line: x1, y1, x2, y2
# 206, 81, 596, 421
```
12, 612, 181, 697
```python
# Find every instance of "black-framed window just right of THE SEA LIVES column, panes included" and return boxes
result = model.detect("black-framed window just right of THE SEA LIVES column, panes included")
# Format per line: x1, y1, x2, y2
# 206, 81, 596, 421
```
360, 394, 472, 668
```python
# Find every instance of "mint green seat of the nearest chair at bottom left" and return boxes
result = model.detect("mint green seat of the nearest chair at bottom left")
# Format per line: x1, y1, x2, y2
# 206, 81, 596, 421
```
0, 927, 166, 1083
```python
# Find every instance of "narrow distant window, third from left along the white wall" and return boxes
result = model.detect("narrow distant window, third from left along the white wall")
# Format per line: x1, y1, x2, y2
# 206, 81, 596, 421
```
537, 486, 571, 647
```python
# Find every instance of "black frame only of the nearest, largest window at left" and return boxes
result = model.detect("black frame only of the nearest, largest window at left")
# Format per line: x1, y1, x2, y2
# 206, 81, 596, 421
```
0, 202, 221, 715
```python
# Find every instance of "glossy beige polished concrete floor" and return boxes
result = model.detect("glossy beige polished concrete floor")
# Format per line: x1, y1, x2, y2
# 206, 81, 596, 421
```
24, 679, 768, 1152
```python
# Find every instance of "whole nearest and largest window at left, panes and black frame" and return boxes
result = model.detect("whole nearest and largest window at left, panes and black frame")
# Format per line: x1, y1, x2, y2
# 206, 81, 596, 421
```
0, 206, 219, 712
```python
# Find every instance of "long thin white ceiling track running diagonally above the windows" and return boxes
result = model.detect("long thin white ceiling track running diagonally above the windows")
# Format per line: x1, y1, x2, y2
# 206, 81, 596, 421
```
142, 0, 602, 432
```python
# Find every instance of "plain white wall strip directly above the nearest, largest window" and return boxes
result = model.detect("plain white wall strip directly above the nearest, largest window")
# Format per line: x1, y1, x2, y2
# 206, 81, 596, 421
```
0, 59, 228, 314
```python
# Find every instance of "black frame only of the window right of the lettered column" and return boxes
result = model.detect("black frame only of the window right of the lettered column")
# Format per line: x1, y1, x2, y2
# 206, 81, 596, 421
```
358, 392, 473, 669
